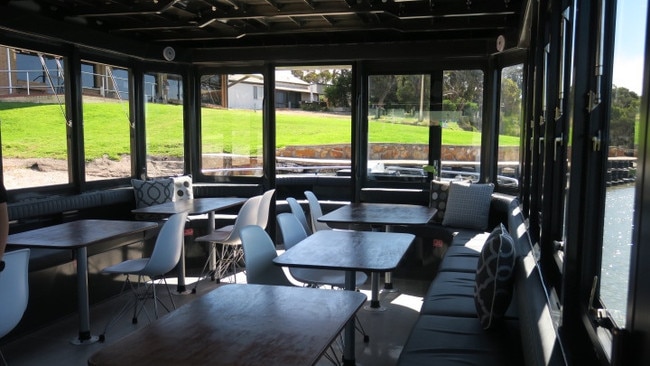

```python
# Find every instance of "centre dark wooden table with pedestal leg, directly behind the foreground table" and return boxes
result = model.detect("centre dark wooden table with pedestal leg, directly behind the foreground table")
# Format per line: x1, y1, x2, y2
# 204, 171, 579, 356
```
273, 230, 415, 365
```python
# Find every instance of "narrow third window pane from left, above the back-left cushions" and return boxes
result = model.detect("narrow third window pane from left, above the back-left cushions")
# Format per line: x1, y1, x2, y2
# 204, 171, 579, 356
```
144, 73, 184, 177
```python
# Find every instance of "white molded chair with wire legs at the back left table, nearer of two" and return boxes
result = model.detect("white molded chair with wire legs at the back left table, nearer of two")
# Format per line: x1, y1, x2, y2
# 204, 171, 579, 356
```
192, 195, 268, 286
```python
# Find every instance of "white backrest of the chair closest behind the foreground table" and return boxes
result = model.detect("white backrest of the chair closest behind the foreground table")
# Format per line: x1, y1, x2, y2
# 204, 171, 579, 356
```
240, 225, 293, 286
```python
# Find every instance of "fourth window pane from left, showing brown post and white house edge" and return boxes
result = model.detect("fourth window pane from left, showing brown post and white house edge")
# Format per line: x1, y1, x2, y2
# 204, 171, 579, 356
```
201, 74, 264, 177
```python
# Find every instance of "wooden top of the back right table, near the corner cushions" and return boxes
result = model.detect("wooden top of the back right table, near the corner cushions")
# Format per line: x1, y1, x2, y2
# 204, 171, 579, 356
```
318, 203, 437, 225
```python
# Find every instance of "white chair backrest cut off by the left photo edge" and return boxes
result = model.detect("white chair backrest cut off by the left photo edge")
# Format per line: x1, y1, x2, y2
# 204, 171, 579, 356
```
0, 249, 29, 338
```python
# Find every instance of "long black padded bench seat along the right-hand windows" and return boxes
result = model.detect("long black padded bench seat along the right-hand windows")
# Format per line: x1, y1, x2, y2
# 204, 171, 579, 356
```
398, 193, 565, 366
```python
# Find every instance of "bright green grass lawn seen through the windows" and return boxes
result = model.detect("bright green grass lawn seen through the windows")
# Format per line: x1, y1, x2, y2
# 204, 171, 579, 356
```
0, 102, 519, 159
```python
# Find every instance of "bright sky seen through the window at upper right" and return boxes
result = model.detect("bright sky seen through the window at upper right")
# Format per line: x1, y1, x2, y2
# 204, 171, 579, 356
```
613, 0, 648, 95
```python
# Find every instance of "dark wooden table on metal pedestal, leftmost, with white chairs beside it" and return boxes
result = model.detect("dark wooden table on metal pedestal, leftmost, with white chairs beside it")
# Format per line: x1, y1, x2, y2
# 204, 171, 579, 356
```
7, 220, 158, 344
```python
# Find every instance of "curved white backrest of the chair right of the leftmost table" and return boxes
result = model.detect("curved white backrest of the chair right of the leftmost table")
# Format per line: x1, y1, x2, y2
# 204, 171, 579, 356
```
140, 211, 187, 276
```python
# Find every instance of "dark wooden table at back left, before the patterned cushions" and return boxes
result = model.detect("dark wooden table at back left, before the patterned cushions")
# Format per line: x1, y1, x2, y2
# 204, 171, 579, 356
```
131, 197, 247, 294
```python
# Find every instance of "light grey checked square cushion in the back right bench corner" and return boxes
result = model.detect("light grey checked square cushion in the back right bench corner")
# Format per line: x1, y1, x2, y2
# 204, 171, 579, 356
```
442, 182, 494, 230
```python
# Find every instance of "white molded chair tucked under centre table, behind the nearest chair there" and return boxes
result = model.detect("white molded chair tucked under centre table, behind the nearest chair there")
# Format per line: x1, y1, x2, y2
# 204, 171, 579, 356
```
278, 212, 368, 288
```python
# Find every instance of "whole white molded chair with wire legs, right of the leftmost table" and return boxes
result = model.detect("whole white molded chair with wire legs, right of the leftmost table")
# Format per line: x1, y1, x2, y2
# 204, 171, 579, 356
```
99, 212, 187, 341
